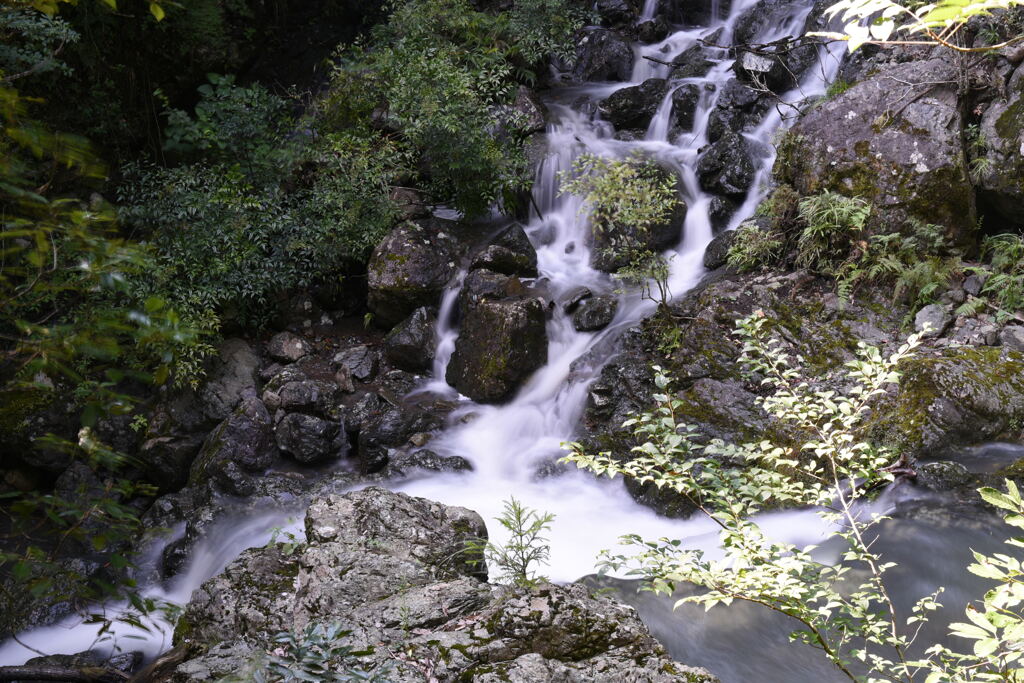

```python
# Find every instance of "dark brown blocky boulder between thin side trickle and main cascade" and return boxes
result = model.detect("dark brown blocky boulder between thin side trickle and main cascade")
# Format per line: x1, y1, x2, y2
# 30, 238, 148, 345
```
445, 299, 548, 403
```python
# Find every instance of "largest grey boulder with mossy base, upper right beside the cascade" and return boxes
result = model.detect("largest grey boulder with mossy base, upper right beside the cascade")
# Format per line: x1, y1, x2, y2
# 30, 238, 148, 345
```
775, 55, 977, 244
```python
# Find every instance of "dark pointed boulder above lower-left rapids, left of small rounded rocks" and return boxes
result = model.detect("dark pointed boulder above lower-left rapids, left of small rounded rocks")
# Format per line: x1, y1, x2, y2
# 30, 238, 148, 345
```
188, 397, 278, 495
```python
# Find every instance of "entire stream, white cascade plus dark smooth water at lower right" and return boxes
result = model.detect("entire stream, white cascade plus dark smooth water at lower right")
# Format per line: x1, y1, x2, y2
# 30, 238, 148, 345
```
0, 0, 1015, 683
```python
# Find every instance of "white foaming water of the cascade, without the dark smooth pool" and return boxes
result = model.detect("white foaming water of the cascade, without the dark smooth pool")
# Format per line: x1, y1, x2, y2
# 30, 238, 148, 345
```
0, 0, 851, 665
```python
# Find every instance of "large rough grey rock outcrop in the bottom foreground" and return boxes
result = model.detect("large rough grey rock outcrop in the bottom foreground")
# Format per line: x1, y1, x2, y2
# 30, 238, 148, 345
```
167, 488, 716, 683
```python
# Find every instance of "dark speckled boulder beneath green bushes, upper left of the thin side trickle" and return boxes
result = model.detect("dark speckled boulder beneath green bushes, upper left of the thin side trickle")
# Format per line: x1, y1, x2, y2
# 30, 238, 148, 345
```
367, 218, 460, 327
